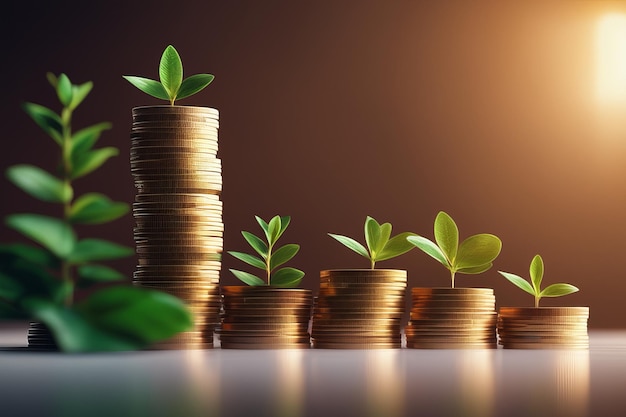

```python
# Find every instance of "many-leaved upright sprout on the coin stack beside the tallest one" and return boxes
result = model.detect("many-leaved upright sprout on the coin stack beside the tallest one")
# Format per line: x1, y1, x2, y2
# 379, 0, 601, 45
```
228, 216, 304, 287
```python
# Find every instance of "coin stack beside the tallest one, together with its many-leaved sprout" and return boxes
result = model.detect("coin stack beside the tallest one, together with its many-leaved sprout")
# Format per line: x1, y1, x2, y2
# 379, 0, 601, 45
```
218, 216, 313, 349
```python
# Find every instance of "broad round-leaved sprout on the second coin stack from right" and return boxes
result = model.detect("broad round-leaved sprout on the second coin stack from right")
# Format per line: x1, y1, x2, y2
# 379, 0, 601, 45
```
407, 211, 502, 288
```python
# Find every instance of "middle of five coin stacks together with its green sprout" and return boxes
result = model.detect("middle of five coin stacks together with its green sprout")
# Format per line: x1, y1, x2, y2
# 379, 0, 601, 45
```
311, 216, 415, 349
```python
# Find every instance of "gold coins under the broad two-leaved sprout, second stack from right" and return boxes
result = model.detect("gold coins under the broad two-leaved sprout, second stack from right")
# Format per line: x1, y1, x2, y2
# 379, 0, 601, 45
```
404, 288, 497, 349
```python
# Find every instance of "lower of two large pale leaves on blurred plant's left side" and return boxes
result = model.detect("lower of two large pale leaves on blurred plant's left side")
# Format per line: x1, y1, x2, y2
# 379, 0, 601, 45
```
5, 213, 76, 258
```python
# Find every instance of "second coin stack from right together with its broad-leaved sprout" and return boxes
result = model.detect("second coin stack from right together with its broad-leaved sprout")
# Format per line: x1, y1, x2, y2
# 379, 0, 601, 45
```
405, 211, 502, 348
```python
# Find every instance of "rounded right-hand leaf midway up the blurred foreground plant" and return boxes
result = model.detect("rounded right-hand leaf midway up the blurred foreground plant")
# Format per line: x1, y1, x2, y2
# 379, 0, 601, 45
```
69, 193, 129, 224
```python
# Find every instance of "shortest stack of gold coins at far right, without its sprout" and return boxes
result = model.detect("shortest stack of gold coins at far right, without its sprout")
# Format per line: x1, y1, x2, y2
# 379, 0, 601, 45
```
498, 307, 589, 349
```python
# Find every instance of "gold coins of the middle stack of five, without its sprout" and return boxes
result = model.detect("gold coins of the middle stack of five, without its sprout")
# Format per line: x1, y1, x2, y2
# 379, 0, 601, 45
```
311, 269, 407, 349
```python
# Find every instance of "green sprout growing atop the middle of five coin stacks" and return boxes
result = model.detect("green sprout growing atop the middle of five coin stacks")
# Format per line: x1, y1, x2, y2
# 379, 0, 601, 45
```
328, 216, 415, 269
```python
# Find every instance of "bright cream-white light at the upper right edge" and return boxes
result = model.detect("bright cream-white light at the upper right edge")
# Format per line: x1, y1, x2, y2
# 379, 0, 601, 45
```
597, 13, 626, 101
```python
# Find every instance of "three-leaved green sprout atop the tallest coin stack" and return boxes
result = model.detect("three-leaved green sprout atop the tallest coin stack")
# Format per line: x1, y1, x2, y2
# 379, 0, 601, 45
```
123, 45, 215, 106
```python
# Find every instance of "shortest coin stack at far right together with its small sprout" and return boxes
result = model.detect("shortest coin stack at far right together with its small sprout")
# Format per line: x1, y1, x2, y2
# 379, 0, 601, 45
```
498, 255, 589, 349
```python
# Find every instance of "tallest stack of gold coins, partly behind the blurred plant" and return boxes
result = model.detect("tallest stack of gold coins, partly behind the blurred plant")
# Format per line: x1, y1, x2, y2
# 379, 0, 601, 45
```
130, 106, 224, 349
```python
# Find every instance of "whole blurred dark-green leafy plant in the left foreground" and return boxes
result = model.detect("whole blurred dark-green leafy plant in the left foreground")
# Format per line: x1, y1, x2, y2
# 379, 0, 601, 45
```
0, 73, 192, 352
